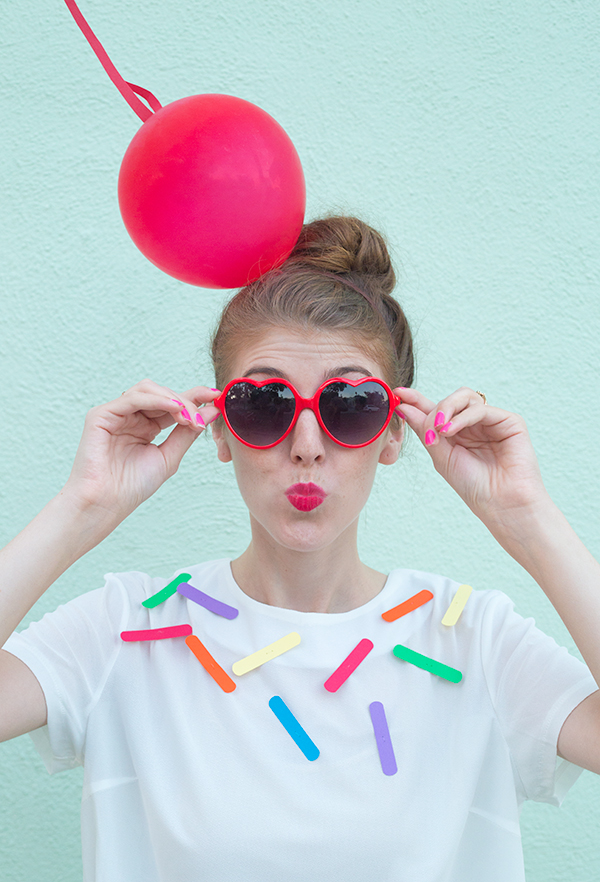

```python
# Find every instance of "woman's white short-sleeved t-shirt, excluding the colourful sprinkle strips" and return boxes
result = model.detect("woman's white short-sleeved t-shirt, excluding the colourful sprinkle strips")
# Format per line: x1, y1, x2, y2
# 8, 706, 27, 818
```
5, 560, 597, 882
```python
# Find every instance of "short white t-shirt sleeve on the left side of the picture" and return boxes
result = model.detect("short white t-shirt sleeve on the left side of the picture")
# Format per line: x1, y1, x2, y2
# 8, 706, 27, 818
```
3, 574, 136, 773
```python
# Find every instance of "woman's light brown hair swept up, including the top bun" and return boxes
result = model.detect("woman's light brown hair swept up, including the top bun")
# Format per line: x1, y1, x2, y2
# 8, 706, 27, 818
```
212, 217, 414, 389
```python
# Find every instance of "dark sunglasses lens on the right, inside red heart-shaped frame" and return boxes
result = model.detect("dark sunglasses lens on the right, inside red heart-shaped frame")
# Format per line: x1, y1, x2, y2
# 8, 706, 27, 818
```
319, 381, 390, 445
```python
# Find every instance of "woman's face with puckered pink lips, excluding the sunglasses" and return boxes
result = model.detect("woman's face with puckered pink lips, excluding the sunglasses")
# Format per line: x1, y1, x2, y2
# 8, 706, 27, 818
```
213, 328, 402, 551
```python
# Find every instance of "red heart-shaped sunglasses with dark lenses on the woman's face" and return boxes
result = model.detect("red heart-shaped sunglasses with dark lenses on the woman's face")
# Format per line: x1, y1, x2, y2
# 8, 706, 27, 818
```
213, 377, 400, 449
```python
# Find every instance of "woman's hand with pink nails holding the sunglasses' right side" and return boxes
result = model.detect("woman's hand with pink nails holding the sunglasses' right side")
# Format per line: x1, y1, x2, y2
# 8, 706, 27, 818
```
395, 388, 548, 524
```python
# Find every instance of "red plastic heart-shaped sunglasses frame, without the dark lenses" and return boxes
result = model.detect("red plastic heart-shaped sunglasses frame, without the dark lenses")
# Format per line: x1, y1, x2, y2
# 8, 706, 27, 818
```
211, 377, 402, 450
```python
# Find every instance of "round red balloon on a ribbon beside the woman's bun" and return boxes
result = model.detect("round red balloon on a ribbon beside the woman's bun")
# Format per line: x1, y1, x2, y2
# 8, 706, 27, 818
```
118, 95, 306, 288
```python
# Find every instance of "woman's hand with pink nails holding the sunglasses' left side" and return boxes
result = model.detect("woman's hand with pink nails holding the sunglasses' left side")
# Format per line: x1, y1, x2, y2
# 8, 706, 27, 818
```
63, 380, 219, 525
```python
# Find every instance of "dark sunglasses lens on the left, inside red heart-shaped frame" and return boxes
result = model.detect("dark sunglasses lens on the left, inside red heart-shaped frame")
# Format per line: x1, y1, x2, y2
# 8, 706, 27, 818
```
225, 383, 296, 447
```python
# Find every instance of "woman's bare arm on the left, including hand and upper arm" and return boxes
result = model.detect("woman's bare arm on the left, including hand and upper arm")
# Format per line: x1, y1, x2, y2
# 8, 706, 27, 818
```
0, 380, 218, 741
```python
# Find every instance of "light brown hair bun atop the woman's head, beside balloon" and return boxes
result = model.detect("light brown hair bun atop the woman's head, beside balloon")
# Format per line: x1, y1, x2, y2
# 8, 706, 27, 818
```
288, 217, 396, 294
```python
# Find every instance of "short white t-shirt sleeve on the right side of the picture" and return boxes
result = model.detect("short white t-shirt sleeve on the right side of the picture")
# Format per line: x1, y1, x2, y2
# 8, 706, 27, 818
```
481, 592, 598, 805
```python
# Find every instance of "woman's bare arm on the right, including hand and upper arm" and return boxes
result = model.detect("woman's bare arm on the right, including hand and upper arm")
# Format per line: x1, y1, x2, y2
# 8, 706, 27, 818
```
397, 389, 600, 773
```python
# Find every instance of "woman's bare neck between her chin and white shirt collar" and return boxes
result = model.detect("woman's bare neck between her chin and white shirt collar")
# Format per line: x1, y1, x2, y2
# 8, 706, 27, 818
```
231, 531, 386, 613
